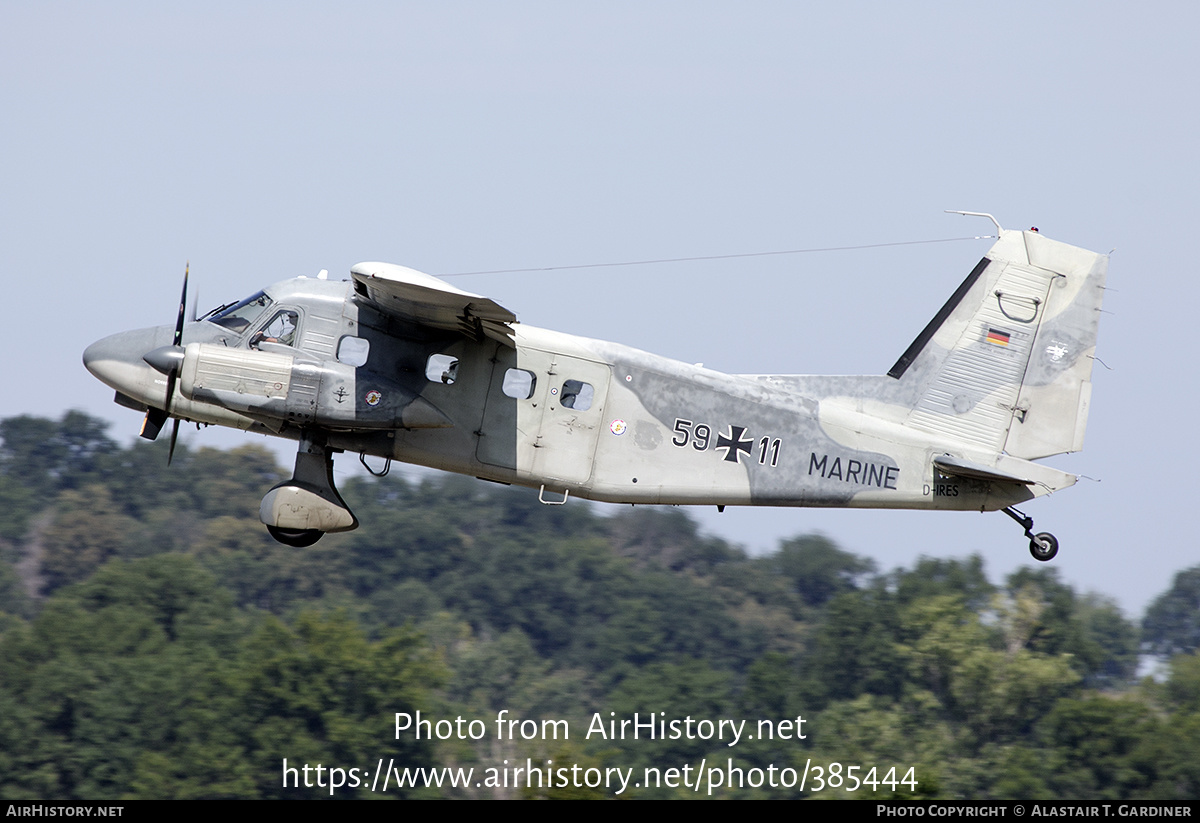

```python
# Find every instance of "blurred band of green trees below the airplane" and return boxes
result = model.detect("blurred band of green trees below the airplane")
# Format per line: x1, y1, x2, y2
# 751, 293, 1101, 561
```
0, 412, 1200, 800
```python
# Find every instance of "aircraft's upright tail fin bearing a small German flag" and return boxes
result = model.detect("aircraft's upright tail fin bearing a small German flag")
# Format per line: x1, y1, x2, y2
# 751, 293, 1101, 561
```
888, 232, 1108, 459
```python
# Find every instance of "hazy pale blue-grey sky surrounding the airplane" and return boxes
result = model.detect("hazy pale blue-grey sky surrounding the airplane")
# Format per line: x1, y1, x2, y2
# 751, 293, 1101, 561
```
0, 2, 1200, 614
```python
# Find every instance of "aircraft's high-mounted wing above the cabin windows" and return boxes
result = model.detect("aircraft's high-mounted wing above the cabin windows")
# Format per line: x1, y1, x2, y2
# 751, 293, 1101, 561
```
350, 263, 517, 347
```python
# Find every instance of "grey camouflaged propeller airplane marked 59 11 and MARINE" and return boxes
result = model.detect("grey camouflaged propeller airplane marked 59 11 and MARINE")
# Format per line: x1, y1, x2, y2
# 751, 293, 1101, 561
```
83, 212, 1108, 560
